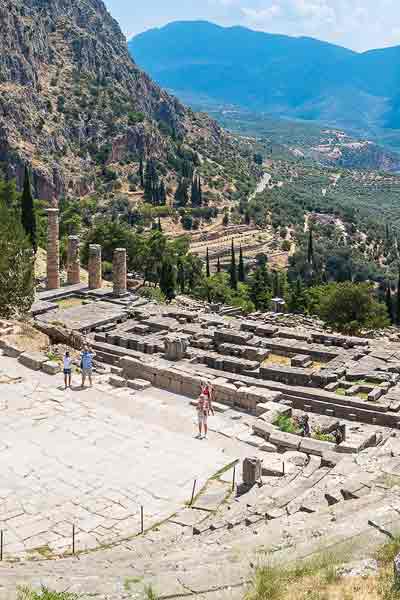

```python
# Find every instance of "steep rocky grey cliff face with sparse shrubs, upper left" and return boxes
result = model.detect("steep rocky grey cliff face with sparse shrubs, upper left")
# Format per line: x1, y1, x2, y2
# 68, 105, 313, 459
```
0, 0, 253, 200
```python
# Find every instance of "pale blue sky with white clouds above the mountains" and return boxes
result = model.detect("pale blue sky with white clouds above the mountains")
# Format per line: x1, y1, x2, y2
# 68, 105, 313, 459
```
105, 0, 400, 50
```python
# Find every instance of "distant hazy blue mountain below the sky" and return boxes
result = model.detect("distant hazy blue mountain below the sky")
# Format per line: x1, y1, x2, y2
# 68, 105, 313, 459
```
129, 21, 400, 134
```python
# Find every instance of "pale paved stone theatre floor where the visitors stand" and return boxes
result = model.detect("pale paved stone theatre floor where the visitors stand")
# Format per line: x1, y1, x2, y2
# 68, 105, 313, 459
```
0, 356, 240, 558
